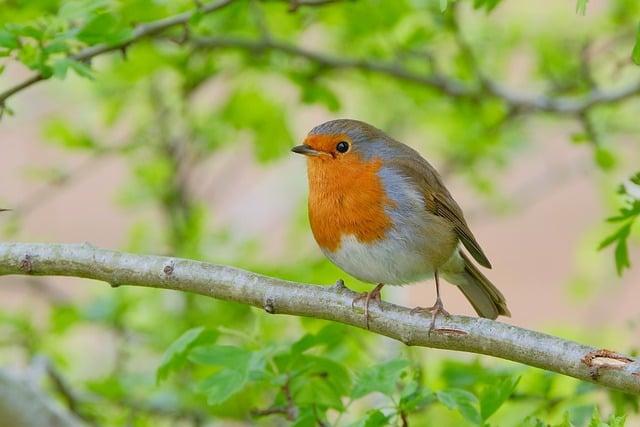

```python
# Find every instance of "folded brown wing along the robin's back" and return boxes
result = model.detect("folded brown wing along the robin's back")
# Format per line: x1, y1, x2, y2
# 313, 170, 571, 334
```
388, 152, 491, 268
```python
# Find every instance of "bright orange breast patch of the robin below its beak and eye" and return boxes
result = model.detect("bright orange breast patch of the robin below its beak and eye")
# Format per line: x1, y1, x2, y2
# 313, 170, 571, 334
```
307, 153, 393, 252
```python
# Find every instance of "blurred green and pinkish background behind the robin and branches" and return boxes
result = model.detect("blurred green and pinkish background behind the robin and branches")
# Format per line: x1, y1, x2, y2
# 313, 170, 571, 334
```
0, 0, 640, 426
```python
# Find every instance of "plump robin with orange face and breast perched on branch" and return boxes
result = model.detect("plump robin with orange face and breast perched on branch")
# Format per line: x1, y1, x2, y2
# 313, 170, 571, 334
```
291, 119, 510, 329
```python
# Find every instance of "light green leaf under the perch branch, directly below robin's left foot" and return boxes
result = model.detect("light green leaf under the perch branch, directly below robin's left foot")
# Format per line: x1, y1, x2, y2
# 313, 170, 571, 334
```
351, 359, 409, 399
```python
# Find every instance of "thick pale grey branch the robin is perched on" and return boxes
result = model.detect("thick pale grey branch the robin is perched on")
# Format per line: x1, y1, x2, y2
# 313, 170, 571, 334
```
0, 243, 640, 394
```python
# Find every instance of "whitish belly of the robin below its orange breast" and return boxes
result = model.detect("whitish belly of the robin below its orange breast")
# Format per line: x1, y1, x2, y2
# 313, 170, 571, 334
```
325, 235, 434, 285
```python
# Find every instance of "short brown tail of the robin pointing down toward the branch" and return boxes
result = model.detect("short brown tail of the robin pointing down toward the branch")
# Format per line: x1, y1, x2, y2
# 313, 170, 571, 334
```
443, 251, 511, 319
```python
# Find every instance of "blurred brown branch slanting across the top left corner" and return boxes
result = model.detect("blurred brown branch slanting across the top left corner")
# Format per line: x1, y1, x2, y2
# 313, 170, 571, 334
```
0, 0, 234, 111
